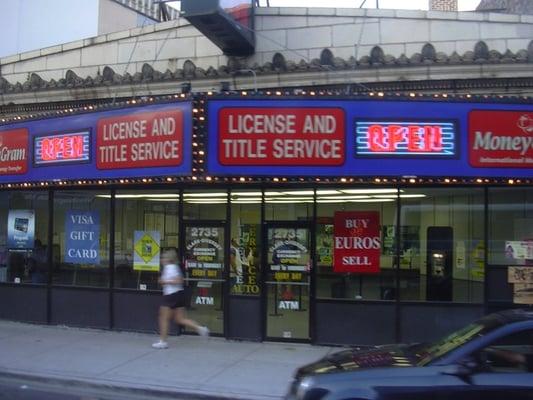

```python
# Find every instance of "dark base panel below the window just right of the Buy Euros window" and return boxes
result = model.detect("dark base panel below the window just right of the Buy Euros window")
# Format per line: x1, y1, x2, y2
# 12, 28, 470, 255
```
400, 303, 485, 343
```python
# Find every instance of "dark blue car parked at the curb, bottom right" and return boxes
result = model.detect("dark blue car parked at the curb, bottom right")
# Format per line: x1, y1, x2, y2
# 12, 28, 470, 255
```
286, 309, 533, 400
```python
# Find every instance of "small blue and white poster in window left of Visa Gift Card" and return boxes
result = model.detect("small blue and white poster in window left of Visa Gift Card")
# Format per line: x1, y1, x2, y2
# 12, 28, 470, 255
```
7, 210, 35, 249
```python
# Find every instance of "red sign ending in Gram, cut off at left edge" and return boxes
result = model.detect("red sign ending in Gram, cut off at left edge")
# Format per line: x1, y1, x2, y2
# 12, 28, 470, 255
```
0, 128, 29, 175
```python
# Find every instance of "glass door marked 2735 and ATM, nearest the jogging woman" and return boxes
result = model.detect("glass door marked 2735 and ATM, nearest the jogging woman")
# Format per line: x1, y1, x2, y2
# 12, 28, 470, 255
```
183, 222, 226, 334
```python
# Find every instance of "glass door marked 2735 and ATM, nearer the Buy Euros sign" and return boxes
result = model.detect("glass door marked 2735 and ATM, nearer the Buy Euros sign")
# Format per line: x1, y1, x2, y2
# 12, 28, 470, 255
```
265, 223, 311, 340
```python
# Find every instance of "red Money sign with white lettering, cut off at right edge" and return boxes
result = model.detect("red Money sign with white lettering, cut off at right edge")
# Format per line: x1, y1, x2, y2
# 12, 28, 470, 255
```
468, 110, 533, 168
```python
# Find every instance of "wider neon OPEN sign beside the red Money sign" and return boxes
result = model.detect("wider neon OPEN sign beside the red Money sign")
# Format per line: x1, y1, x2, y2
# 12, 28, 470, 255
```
356, 121, 457, 157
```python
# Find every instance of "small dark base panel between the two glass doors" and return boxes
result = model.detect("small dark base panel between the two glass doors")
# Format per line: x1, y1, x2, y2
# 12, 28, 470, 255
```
228, 297, 261, 341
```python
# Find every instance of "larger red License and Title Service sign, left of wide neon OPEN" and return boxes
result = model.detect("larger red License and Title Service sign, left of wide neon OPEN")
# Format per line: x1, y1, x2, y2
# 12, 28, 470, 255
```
218, 107, 345, 166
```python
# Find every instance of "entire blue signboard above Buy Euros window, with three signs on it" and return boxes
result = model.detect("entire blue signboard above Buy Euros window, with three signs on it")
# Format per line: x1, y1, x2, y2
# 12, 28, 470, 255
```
207, 99, 533, 178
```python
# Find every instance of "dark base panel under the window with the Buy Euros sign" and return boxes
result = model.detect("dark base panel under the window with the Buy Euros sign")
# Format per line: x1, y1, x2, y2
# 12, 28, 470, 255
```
315, 301, 396, 345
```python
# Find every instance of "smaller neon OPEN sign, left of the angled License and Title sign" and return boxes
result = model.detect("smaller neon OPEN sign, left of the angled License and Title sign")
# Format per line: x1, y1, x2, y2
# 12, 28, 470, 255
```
33, 130, 91, 166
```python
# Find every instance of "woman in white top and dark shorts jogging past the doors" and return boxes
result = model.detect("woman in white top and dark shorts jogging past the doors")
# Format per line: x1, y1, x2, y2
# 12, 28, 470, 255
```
152, 249, 209, 349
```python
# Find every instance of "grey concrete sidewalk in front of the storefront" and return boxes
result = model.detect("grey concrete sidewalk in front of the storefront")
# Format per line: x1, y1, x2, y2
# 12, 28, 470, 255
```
0, 320, 338, 400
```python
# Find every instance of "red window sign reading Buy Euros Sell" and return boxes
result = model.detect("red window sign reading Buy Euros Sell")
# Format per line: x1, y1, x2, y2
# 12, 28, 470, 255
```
333, 211, 381, 274
